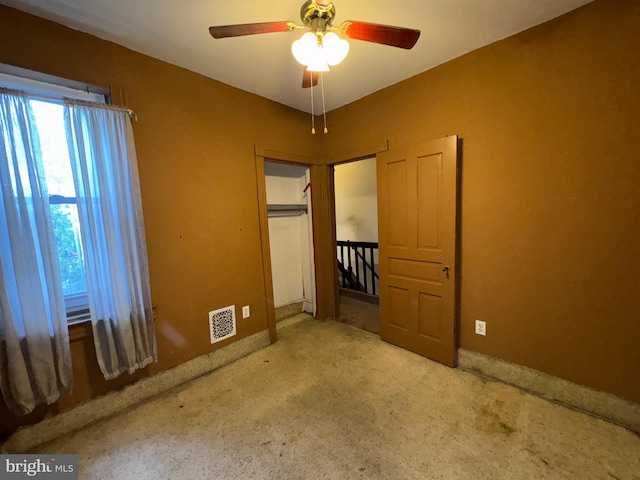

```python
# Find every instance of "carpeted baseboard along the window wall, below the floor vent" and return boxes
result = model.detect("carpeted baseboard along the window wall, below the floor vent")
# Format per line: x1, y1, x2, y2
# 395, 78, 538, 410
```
0, 330, 271, 453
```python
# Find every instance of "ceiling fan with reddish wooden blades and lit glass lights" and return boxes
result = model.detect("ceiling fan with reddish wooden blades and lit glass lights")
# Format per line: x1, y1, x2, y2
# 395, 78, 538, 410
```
209, 0, 420, 88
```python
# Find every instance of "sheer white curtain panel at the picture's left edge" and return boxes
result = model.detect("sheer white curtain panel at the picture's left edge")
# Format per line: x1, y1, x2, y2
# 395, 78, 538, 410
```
0, 91, 72, 414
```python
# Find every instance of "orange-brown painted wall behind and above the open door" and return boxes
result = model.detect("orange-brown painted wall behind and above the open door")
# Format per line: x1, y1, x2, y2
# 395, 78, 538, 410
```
324, 0, 640, 402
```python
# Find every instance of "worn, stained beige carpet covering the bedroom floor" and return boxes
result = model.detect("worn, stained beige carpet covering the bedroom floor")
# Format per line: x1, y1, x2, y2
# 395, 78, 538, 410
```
35, 316, 640, 480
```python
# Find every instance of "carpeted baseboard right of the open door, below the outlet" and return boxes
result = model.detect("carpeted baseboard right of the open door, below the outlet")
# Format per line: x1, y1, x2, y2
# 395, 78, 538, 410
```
458, 349, 640, 433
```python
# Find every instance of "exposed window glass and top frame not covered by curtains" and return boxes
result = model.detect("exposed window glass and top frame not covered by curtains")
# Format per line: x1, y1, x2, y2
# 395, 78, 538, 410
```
0, 66, 108, 321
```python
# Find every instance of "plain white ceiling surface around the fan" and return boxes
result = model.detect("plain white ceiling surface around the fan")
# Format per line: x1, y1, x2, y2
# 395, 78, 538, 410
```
0, 0, 592, 113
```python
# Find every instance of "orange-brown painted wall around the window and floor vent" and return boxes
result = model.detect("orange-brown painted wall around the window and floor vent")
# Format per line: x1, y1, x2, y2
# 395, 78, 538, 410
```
0, 6, 313, 433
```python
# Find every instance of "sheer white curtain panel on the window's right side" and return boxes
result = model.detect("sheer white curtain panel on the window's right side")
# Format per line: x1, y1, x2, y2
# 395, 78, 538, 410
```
65, 103, 157, 379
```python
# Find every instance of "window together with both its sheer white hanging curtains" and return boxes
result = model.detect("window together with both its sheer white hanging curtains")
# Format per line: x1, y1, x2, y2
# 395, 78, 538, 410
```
0, 65, 157, 406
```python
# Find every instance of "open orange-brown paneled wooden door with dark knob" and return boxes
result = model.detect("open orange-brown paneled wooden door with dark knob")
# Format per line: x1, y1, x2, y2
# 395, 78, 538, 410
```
377, 136, 458, 367
